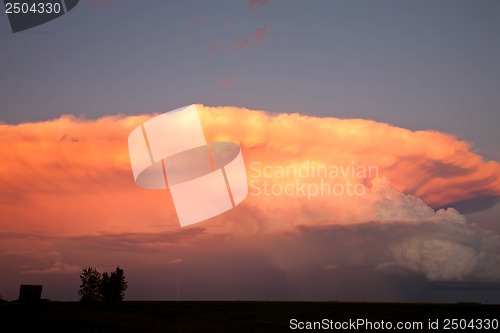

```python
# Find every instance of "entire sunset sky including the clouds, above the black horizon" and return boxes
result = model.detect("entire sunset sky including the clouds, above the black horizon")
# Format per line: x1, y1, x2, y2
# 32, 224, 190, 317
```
0, 0, 500, 303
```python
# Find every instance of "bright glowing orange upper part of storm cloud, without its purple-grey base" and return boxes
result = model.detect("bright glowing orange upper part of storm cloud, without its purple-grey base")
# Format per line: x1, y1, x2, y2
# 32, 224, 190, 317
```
0, 107, 500, 233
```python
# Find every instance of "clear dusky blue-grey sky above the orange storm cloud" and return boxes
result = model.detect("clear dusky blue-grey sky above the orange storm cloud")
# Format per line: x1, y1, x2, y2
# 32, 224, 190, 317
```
0, 0, 500, 159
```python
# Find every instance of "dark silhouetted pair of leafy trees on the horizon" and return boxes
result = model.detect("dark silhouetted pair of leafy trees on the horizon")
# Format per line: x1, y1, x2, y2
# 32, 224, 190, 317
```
78, 266, 128, 302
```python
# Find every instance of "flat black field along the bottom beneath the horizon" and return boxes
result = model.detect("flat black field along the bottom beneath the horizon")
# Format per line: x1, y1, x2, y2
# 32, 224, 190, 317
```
0, 301, 500, 332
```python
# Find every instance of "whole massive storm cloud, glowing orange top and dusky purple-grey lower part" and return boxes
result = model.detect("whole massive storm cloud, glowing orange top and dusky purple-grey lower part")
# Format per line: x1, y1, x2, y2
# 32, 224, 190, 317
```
0, 106, 500, 294
